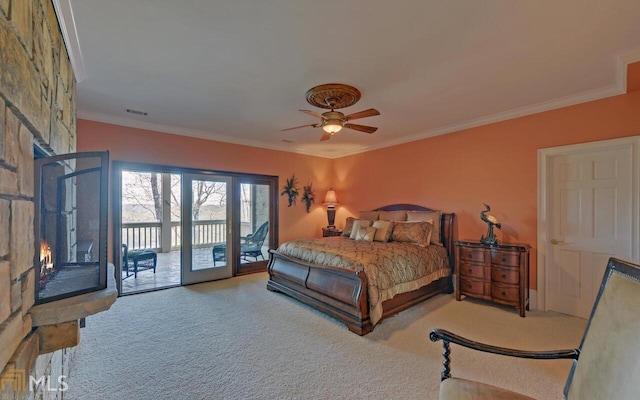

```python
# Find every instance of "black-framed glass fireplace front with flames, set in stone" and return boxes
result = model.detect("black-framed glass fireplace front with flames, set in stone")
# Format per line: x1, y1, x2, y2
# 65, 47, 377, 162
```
34, 152, 109, 304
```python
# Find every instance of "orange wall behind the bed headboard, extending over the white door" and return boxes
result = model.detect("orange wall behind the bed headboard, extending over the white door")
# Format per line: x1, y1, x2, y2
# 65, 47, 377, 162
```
334, 91, 640, 289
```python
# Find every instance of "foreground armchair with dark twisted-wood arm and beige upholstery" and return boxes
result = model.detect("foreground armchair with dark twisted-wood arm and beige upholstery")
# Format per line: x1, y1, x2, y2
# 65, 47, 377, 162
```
429, 258, 640, 400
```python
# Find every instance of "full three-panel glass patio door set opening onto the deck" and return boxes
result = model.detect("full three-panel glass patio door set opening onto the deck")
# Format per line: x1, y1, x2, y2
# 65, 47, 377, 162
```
112, 161, 278, 294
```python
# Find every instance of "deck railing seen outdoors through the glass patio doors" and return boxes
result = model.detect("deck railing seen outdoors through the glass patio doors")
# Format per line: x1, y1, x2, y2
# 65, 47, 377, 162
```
122, 219, 251, 251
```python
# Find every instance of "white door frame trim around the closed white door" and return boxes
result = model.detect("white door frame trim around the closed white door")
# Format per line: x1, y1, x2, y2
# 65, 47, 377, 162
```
532, 136, 640, 310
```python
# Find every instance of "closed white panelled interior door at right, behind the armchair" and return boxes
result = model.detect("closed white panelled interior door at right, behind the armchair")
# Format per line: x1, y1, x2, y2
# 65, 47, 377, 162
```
545, 145, 637, 318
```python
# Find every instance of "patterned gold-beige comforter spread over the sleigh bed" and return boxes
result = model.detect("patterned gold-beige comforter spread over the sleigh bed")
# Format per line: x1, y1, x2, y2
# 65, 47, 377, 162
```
278, 236, 451, 325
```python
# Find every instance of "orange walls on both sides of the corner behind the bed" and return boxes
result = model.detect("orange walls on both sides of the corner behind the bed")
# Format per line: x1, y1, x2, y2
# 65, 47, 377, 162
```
77, 76, 640, 289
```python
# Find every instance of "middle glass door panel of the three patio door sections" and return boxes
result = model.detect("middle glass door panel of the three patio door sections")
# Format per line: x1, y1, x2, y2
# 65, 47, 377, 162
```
182, 174, 233, 284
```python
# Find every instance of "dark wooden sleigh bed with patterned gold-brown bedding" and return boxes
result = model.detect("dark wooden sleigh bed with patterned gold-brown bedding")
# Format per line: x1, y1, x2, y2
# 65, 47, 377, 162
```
267, 204, 455, 335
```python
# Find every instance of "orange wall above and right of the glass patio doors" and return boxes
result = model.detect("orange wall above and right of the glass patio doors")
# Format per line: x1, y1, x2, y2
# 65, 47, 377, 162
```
77, 119, 333, 253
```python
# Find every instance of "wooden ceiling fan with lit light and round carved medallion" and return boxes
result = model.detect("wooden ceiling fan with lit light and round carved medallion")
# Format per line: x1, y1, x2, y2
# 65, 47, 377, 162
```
283, 83, 380, 140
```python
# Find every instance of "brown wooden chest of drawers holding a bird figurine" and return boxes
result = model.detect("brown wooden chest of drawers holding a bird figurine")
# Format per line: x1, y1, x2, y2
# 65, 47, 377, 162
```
455, 240, 531, 317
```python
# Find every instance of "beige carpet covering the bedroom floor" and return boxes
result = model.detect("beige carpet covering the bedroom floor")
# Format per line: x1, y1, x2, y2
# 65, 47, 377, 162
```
65, 273, 586, 400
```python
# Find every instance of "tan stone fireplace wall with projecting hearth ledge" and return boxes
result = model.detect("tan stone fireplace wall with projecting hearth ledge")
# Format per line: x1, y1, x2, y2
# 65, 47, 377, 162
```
0, 0, 117, 400
